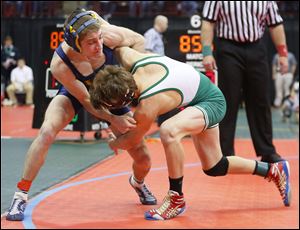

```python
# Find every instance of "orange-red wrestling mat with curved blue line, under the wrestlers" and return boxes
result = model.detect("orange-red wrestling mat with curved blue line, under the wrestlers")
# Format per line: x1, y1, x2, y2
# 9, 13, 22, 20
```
1, 138, 299, 229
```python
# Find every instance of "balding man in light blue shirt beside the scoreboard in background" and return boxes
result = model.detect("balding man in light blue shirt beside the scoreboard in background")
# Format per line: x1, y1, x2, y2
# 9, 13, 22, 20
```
144, 15, 168, 55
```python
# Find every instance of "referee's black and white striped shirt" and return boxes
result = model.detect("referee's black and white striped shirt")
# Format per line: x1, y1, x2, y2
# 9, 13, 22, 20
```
202, 1, 283, 42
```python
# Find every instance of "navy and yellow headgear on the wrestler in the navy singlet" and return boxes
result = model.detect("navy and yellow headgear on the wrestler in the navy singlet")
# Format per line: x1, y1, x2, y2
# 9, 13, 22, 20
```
64, 11, 98, 53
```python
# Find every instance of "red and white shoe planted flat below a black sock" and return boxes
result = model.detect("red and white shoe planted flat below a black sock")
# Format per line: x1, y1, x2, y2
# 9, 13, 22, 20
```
145, 190, 185, 220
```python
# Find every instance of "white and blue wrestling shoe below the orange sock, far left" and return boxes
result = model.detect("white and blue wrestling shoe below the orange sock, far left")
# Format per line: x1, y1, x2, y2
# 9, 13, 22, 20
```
6, 192, 28, 221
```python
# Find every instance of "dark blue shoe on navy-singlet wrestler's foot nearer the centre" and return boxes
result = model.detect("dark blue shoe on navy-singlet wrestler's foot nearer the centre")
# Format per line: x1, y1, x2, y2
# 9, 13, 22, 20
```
129, 175, 157, 205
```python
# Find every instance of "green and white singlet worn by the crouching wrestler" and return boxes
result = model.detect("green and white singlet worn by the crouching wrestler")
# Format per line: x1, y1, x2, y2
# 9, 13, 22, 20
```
131, 56, 226, 129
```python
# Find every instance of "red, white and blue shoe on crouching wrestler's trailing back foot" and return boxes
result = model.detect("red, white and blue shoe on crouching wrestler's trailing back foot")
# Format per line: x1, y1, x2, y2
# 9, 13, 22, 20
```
266, 161, 291, 206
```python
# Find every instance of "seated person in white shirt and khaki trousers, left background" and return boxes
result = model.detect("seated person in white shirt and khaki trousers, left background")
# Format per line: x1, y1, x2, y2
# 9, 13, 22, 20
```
6, 58, 33, 105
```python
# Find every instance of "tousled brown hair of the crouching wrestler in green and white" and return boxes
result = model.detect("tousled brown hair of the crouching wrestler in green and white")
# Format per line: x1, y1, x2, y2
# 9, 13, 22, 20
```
89, 65, 137, 109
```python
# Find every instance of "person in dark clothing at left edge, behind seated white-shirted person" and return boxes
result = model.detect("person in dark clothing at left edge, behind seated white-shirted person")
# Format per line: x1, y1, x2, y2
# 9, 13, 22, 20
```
1, 36, 20, 98
